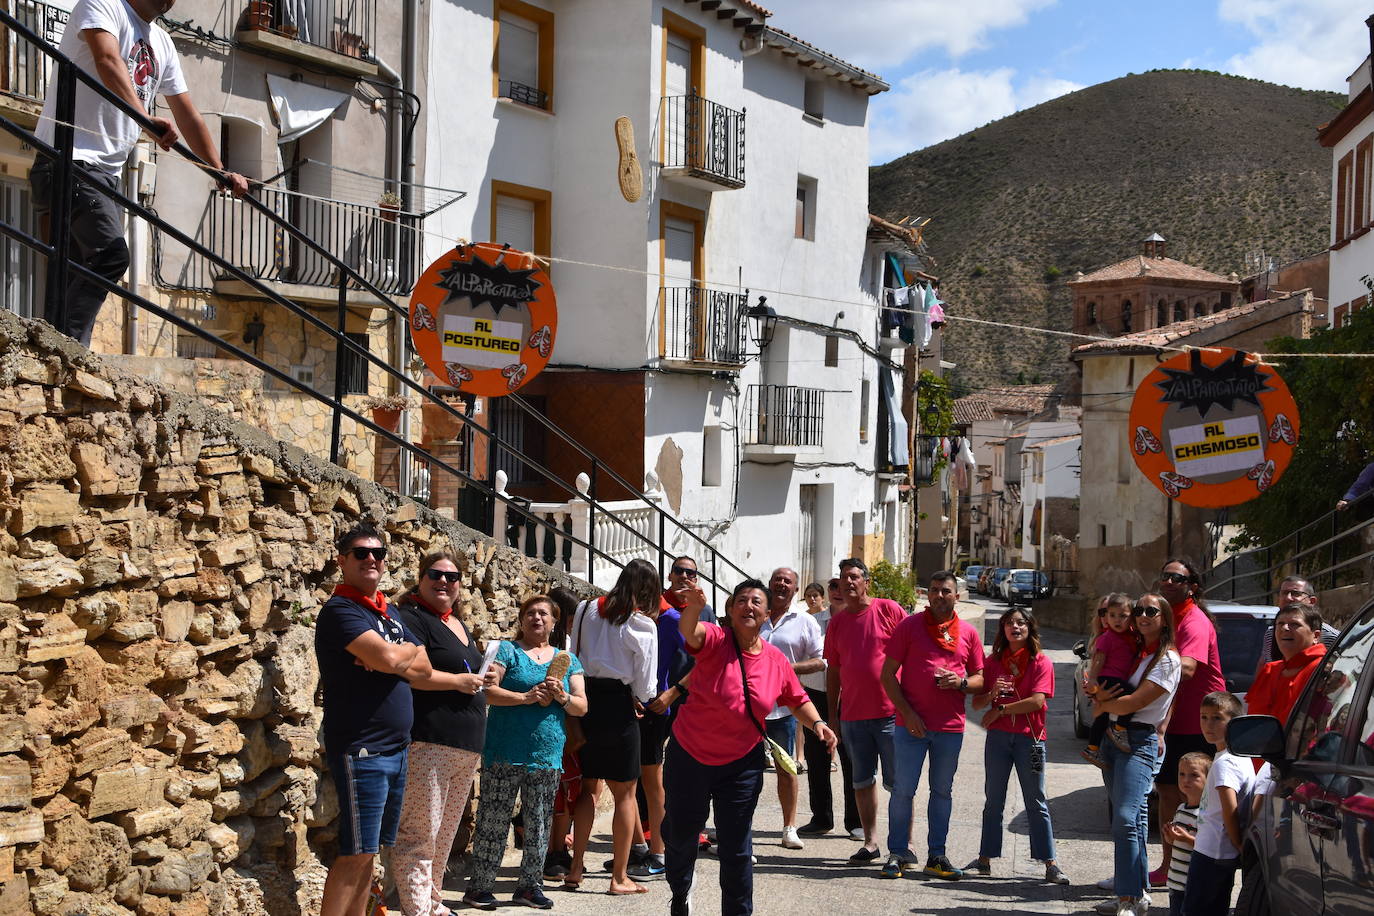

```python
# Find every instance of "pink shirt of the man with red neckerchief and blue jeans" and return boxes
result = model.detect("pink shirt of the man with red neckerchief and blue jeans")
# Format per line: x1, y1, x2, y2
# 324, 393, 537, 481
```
888, 611, 982, 732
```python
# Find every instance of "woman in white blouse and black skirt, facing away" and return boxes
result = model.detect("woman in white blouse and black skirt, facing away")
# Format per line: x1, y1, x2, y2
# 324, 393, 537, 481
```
563, 560, 662, 894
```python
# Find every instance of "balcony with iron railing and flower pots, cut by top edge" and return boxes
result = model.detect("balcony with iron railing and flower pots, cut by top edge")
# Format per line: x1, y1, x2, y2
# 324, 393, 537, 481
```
235, 0, 378, 77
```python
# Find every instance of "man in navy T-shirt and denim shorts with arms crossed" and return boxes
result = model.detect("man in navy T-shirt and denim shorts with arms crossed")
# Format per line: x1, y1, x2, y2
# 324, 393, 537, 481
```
315, 525, 431, 916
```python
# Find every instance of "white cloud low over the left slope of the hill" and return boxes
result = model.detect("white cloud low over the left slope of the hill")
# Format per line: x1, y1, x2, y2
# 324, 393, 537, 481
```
868, 67, 1083, 163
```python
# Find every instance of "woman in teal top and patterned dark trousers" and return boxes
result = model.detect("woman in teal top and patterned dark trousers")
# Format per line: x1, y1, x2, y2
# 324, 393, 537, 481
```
463, 595, 587, 909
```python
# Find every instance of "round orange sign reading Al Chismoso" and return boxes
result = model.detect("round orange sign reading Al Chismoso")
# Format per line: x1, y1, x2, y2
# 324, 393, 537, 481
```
1131, 347, 1298, 507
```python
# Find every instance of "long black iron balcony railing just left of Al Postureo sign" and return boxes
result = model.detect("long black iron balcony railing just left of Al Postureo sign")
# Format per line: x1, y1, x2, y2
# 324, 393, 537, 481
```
209, 187, 422, 295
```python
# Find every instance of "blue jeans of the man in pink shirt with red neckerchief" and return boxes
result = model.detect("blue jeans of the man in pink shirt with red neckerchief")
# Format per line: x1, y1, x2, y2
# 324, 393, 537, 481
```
888, 728, 963, 856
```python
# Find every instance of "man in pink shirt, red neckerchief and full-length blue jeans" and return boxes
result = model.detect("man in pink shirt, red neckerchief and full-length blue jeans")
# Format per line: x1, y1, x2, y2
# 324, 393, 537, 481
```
882, 571, 982, 880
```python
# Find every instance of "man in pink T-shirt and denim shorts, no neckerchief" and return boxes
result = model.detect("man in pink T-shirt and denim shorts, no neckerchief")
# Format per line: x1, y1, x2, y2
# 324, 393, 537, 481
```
824, 558, 907, 864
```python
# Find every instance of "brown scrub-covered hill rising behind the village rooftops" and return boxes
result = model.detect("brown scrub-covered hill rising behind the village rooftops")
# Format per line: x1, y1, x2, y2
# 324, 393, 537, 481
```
868, 70, 1345, 386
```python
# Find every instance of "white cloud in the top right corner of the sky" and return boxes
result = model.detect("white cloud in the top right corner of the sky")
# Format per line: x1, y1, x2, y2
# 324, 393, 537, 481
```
1217, 0, 1370, 91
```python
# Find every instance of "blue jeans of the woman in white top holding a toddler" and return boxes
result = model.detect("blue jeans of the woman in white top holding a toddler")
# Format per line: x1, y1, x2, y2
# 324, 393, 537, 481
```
1102, 726, 1158, 897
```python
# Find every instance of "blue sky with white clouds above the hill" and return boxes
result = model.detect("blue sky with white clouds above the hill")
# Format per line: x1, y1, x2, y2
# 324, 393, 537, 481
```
764, 0, 1374, 163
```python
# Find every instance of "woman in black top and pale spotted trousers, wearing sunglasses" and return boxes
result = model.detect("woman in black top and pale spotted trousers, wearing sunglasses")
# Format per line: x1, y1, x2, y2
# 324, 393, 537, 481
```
392, 551, 486, 916
